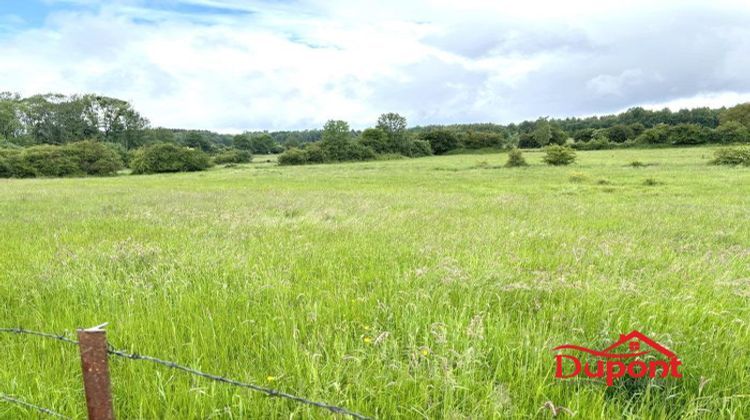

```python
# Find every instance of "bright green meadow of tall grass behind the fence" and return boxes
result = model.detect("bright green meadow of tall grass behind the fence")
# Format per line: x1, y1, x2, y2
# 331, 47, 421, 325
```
0, 148, 750, 419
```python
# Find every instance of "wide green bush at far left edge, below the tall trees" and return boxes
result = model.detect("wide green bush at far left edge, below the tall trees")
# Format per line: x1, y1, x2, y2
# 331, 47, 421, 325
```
0, 141, 123, 178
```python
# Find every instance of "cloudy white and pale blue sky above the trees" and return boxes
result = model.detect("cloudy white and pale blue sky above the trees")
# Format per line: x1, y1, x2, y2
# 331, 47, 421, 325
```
0, 0, 750, 133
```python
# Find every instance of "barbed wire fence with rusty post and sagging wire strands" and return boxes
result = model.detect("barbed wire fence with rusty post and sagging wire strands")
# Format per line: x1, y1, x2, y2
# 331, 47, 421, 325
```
0, 324, 371, 419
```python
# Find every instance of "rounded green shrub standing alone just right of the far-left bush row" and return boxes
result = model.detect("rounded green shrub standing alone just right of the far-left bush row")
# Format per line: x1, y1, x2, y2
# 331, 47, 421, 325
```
130, 143, 211, 174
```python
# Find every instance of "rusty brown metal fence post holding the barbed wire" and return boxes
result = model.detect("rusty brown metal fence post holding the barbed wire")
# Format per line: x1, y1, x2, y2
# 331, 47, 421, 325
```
78, 324, 115, 420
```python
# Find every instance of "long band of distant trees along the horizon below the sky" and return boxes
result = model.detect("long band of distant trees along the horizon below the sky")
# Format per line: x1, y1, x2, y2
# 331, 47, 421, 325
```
0, 92, 750, 171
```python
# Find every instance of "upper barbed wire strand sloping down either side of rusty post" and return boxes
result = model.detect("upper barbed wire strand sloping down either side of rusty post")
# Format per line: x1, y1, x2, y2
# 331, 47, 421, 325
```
0, 328, 371, 419
